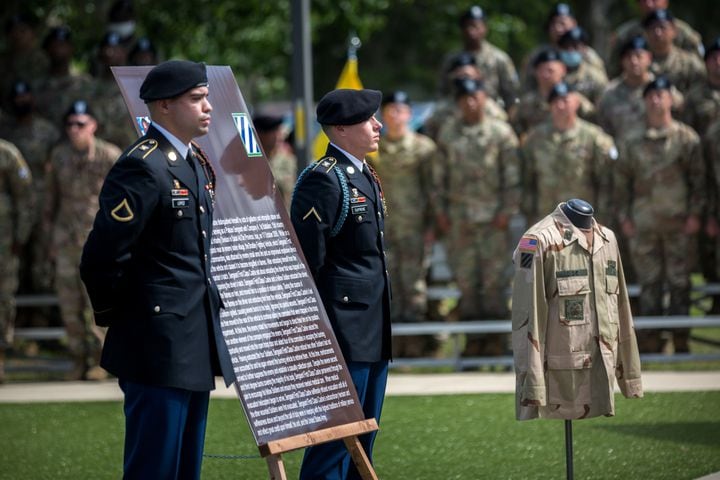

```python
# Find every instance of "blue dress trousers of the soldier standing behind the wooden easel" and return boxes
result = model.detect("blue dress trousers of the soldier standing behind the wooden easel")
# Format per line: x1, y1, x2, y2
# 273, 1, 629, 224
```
300, 360, 388, 480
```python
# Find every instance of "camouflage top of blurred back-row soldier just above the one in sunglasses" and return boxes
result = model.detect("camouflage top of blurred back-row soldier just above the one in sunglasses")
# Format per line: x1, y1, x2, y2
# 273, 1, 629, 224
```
35, 74, 92, 126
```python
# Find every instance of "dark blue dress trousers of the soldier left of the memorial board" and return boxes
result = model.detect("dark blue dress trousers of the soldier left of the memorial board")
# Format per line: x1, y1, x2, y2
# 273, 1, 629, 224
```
120, 380, 210, 480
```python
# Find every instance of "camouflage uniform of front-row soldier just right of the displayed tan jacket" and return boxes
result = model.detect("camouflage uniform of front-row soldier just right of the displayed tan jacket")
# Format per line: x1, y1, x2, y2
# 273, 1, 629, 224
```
615, 121, 706, 350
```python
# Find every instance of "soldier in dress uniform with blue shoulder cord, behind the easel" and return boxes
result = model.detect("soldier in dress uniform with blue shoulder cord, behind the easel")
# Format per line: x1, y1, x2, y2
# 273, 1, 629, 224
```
291, 89, 391, 479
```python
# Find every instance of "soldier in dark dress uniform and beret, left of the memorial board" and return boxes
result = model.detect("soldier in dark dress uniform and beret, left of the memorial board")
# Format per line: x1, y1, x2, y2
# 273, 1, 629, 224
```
80, 61, 234, 479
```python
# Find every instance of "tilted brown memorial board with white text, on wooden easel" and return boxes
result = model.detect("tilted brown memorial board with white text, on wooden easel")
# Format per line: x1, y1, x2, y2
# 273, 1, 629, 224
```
112, 66, 364, 445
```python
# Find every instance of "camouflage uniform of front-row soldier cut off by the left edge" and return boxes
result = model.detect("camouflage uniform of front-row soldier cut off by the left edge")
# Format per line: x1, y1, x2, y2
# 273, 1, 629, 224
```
0, 139, 32, 383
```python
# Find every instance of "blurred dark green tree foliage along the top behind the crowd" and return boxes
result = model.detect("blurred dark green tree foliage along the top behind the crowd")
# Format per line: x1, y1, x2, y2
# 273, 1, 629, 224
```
0, 0, 720, 102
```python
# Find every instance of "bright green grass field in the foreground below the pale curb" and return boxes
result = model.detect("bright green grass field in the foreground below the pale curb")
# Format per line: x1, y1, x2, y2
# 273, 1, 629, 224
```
0, 392, 720, 480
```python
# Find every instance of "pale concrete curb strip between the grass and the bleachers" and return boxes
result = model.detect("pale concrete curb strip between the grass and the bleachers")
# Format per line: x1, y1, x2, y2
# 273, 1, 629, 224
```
0, 371, 720, 403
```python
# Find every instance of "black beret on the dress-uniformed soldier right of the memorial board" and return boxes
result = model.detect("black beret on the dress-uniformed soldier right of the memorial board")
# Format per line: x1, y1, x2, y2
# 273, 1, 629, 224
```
316, 88, 382, 125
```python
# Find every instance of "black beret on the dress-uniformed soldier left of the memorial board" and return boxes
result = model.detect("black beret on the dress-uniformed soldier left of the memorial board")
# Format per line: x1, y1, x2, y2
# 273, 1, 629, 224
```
140, 60, 208, 103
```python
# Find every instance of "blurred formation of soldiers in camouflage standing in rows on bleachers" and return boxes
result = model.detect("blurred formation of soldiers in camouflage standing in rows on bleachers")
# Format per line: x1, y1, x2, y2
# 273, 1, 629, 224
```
0, 0, 720, 379
